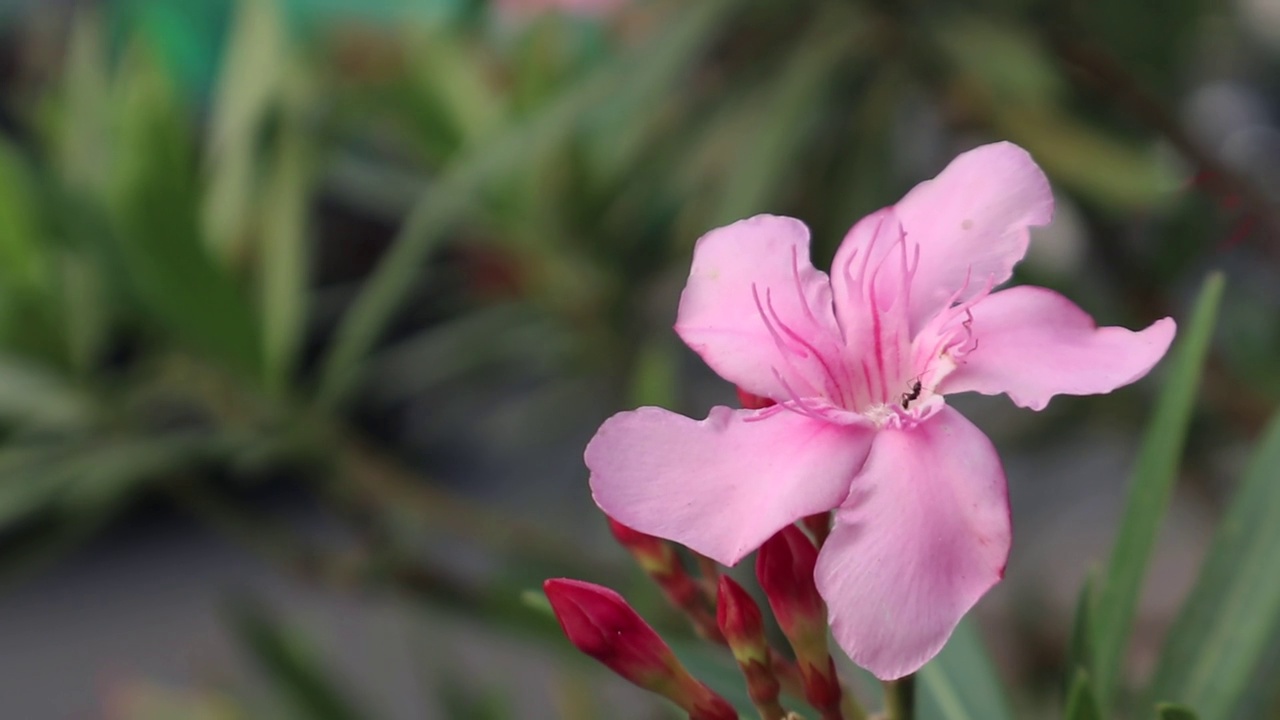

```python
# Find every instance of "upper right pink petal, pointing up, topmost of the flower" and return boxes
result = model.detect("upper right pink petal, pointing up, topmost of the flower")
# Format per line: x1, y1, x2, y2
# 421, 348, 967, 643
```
893, 142, 1053, 328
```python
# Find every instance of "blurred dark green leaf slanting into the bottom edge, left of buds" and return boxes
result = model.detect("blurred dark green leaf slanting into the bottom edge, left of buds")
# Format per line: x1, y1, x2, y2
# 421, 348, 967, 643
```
232, 603, 370, 720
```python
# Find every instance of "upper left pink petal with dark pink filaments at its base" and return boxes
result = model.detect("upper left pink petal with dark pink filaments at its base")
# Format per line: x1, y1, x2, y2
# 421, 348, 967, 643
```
676, 215, 838, 401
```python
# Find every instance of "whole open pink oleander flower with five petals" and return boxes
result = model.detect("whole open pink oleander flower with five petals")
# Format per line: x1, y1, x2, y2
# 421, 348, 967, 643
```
585, 143, 1175, 679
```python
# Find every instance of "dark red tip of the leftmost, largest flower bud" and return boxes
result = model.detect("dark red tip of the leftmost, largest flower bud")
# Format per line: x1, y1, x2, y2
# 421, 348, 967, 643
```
543, 578, 677, 687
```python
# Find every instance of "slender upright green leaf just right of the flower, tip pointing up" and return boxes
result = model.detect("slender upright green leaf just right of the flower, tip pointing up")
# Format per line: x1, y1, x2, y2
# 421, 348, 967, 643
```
1091, 274, 1224, 707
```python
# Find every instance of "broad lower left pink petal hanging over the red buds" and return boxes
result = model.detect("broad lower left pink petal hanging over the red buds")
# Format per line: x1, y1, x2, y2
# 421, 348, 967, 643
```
585, 407, 872, 565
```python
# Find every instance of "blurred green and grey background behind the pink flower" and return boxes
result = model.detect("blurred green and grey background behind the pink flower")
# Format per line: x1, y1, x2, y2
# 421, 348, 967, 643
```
0, 0, 1280, 720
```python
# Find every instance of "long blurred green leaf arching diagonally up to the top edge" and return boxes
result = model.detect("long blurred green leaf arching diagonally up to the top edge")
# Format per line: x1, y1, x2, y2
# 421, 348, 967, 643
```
320, 0, 736, 405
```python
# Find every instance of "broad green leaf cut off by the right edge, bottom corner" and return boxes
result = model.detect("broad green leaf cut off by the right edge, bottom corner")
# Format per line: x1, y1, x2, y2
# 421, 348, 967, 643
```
1146, 404, 1280, 720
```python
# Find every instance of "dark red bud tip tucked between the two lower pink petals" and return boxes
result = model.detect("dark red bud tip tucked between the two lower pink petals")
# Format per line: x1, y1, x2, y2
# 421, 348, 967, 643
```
755, 525, 826, 632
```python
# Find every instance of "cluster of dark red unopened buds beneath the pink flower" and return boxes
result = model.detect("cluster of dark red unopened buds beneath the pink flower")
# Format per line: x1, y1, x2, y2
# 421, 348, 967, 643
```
543, 519, 880, 720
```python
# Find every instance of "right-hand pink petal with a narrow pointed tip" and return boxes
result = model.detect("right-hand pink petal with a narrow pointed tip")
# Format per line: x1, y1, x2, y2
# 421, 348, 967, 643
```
941, 286, 1176, 410
